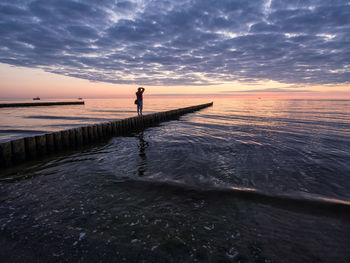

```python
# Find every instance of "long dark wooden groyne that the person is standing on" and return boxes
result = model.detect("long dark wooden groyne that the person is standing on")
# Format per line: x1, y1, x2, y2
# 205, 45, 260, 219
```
0, 102, 213, 167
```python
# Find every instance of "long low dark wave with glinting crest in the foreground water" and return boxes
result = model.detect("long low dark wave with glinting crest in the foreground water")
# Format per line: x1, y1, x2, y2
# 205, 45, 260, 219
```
115, 178, 350, 217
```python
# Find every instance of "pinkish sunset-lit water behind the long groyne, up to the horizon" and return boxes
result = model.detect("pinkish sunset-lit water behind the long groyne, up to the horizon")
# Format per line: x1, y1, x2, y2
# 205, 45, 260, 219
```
0, 96, 208, 142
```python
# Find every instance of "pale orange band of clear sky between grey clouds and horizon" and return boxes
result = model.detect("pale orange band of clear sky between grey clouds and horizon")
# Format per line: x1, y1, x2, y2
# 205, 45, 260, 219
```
0, 63, 350, 99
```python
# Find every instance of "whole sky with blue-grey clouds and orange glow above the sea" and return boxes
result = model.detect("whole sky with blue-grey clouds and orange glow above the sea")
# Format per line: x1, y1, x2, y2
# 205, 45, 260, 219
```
0, 0, 350, 98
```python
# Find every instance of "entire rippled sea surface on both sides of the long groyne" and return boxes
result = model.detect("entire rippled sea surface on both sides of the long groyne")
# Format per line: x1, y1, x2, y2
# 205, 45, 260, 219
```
0, 98, 350, 262
